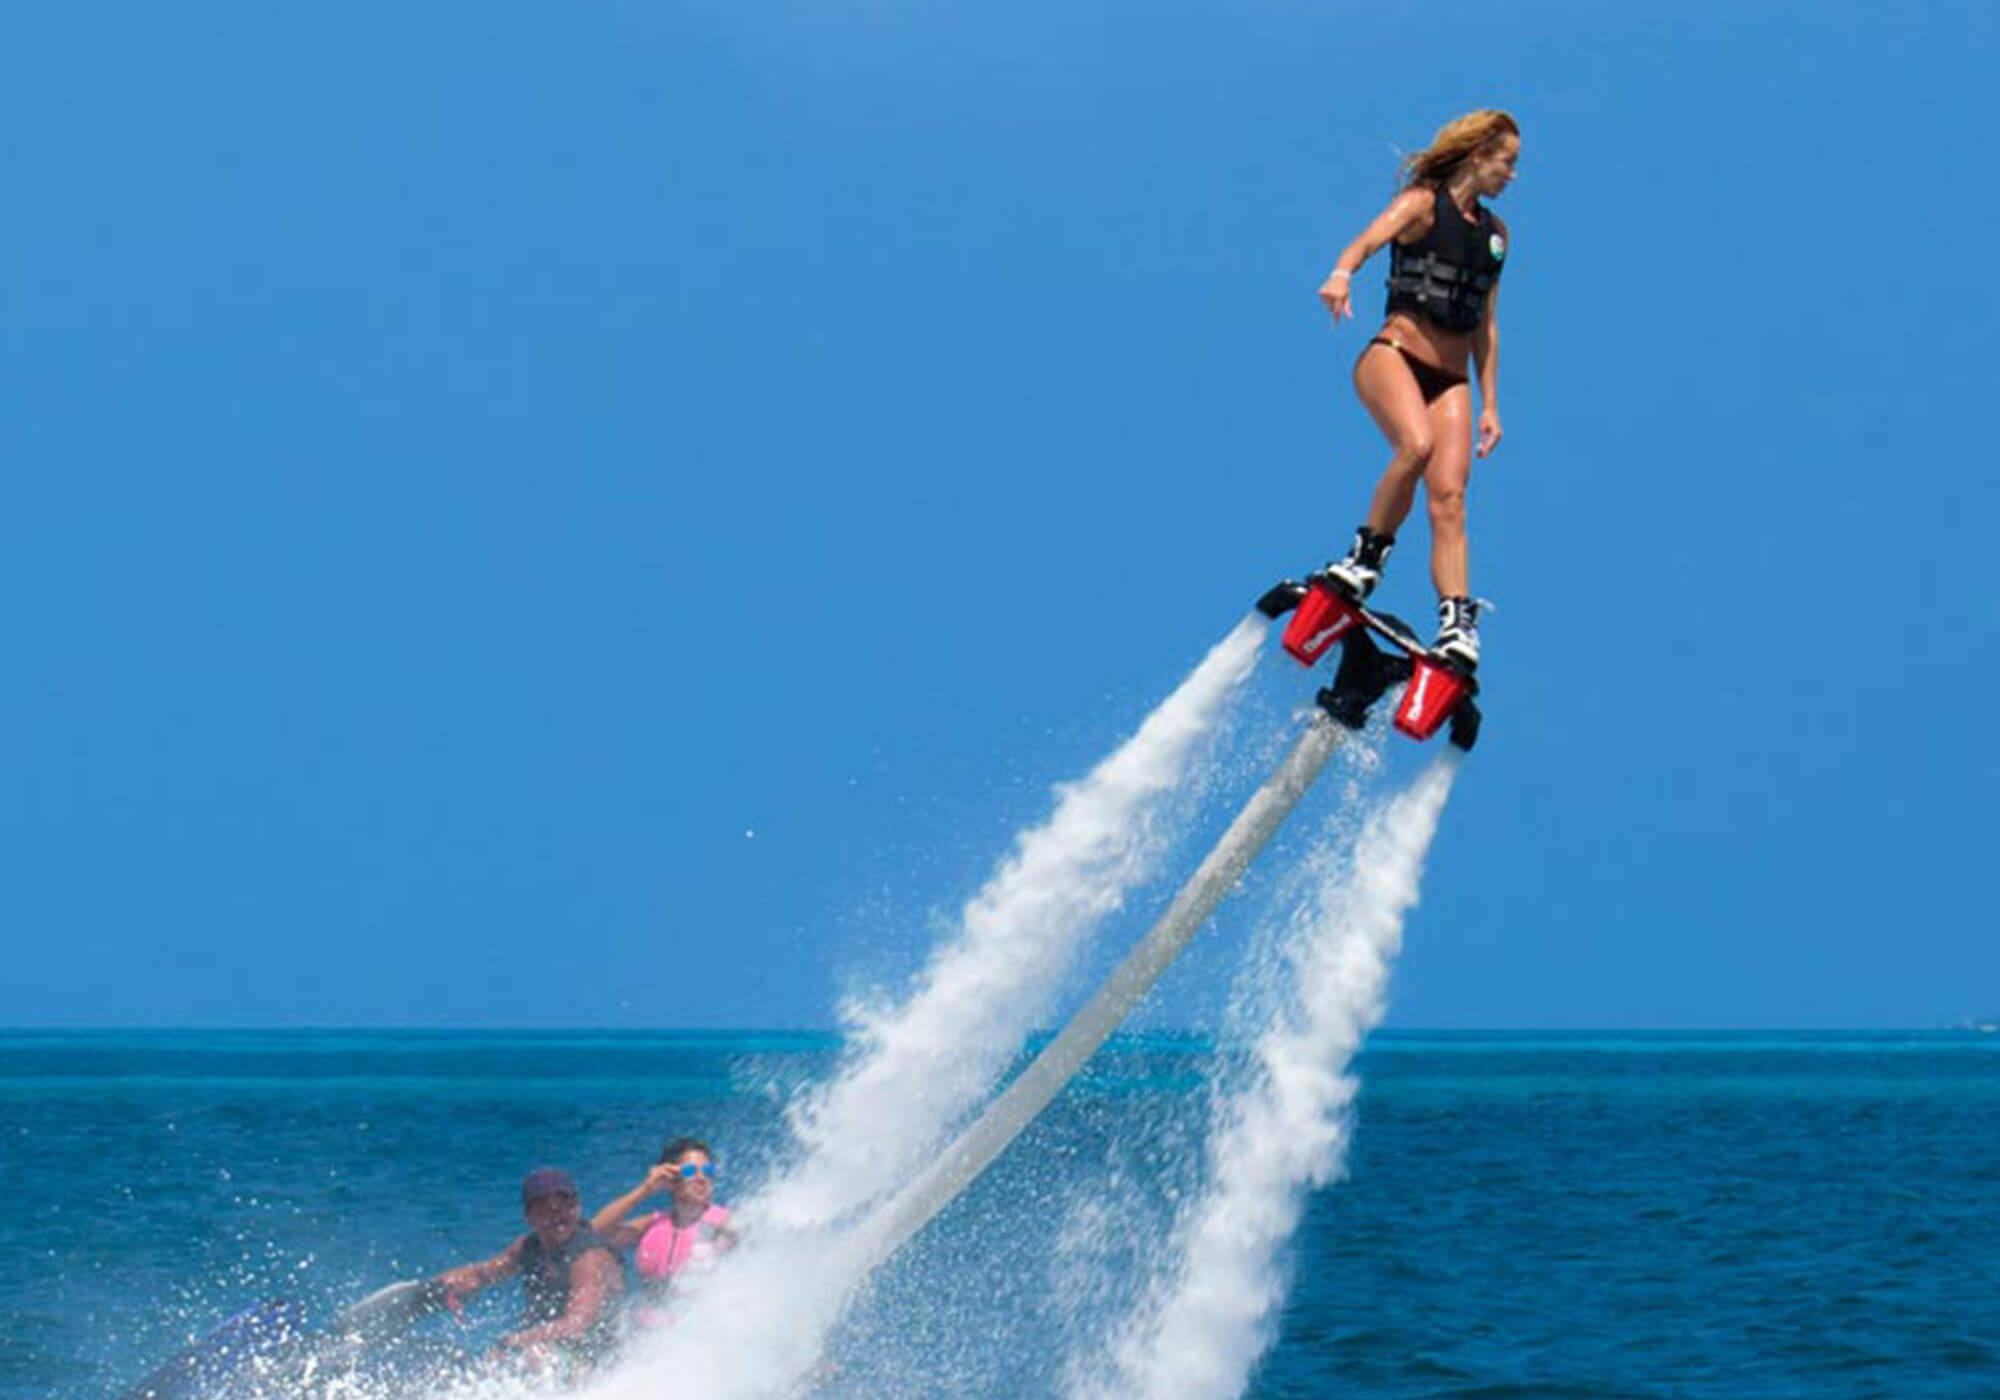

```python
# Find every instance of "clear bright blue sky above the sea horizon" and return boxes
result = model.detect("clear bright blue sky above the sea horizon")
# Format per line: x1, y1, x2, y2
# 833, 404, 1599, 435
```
0, 0, 2000, 1026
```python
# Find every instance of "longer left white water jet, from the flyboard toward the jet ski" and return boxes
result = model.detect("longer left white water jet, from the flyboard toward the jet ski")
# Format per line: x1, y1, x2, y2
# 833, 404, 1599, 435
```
586, 614, 1268, 1400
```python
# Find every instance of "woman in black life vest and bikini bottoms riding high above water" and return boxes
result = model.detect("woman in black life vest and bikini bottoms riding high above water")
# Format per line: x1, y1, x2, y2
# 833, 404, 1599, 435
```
1320, 110, 1520, 666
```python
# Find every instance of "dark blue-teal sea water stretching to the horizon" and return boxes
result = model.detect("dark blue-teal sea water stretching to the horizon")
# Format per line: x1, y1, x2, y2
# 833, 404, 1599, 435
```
0, 1032, 2000, 1400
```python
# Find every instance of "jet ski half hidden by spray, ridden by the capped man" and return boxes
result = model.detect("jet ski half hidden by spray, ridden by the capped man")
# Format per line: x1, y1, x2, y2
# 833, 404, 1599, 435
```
118, 1280, 446, 1400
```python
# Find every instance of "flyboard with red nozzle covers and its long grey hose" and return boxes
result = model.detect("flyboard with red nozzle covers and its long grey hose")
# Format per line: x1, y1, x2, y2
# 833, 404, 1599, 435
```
854, 576, 1480, 1268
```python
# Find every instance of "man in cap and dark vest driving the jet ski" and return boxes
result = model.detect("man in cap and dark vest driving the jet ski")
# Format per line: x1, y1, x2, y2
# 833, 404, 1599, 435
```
438, 1166, 624, 1368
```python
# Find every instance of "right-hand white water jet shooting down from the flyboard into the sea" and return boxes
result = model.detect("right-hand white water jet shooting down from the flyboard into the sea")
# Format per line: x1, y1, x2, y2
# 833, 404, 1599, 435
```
1070, 750, 1458, 1400
